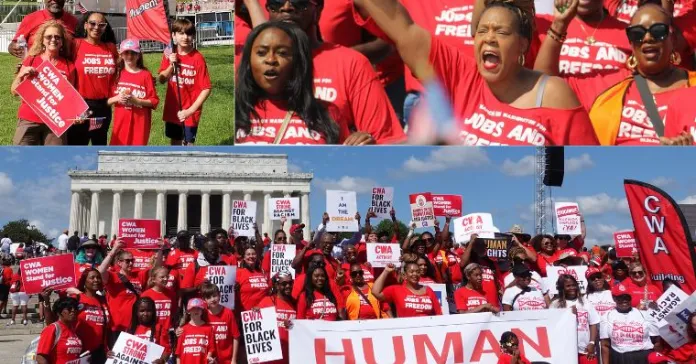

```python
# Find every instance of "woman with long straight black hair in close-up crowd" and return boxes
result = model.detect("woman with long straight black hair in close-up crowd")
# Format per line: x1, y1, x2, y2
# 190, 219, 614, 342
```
235, 22, 342, 144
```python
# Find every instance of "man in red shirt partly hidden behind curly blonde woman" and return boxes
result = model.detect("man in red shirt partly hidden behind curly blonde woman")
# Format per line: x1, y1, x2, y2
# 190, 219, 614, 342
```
7, 0, 77, 58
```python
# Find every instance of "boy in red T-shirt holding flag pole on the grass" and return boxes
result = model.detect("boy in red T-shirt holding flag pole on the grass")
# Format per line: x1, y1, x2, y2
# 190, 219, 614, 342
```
158, 19, 211, 145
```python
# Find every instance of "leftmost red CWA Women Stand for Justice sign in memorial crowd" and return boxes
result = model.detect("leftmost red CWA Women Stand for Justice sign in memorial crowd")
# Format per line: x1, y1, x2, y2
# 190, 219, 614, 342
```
19, 254, 77, 294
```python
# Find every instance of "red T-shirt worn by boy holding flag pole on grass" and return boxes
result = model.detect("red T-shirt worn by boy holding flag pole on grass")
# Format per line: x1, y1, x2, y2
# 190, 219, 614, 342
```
158, 49, 211, 126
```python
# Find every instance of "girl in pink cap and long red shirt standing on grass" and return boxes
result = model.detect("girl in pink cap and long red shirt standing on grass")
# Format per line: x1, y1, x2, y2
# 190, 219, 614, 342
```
108, 39, 159, 145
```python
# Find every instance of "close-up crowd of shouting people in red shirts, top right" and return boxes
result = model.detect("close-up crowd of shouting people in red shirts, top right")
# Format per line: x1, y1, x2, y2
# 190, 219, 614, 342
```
235, 0, 696, 145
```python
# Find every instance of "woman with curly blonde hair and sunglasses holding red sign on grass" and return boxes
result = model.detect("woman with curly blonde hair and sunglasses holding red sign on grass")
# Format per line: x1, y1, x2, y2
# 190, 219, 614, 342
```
11, 20, 76, 145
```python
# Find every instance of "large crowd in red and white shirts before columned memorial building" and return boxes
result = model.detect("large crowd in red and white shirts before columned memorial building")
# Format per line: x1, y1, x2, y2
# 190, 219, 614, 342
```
12, 205, 696, 364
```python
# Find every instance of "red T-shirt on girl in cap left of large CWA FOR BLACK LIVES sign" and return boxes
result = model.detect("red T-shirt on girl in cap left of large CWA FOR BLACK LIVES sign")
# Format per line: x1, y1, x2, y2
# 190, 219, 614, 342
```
176, 322, 217, 364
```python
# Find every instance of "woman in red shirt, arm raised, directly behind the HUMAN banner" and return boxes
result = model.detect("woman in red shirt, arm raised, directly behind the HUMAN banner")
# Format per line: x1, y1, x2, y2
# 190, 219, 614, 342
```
372, 262, 442, 317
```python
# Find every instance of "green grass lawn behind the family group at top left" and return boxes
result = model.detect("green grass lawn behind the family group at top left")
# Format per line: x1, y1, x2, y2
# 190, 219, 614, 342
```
0, 47, 234, 145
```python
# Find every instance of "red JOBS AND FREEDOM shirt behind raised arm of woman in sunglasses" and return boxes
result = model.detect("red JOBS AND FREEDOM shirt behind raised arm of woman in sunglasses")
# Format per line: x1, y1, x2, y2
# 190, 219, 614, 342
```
536, 15, 632, 75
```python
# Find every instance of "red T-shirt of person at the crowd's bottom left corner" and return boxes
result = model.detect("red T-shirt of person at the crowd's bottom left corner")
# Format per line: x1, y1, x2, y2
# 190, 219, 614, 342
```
36, 321, 83, 364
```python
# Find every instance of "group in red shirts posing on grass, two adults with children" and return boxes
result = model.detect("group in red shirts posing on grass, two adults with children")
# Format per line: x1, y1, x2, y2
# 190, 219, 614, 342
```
8, 0, 211, 145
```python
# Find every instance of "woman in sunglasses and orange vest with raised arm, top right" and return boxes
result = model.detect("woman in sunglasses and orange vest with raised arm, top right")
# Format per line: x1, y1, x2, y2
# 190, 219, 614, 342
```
534, 0, 696, 145
